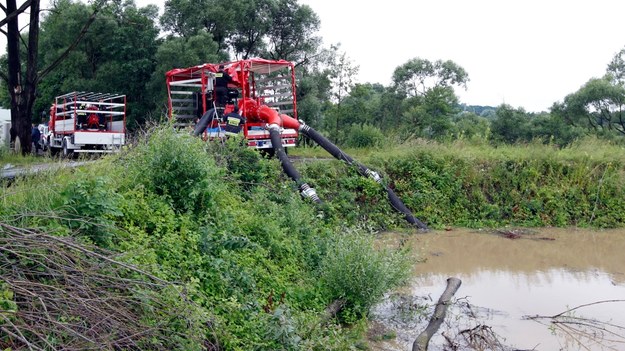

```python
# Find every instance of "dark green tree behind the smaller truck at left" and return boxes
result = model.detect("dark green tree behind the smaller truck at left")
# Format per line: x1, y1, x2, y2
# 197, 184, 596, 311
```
35, 0, 164, 128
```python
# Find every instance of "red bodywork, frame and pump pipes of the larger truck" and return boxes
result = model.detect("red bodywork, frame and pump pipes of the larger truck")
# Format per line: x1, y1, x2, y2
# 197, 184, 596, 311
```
166, 58, 299, 148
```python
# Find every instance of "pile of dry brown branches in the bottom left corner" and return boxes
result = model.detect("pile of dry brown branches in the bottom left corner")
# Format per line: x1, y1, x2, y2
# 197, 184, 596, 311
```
0, 222, 210, 350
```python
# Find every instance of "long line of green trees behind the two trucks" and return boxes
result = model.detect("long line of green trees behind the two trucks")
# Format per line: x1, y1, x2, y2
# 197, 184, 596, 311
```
0, 0, 625, 153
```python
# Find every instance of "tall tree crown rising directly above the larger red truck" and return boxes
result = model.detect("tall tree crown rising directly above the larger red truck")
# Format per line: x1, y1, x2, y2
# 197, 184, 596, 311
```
161, 0, 320, 63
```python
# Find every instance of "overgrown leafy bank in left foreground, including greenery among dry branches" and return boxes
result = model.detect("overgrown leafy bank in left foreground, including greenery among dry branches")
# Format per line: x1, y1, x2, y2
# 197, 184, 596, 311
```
0, 127, 414, 350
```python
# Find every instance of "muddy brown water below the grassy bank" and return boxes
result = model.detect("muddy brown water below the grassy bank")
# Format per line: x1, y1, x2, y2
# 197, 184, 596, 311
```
370, 228, 625, 351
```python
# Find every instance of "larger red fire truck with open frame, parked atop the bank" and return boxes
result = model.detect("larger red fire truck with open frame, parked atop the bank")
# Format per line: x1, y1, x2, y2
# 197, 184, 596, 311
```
166, 58, 298, 153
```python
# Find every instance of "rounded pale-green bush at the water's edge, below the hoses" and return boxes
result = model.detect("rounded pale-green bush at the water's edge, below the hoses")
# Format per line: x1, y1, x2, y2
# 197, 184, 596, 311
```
320, 231, 410, 320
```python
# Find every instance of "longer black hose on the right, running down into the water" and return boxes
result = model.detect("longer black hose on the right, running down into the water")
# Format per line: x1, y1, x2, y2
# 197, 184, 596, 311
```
300, 124, 428, 230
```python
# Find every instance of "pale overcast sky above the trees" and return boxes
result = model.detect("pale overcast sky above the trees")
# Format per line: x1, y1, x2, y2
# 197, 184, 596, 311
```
0, 0, 625, 112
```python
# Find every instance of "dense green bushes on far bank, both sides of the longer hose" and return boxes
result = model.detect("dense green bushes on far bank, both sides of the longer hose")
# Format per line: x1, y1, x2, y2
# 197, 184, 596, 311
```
294, 140, 625, 229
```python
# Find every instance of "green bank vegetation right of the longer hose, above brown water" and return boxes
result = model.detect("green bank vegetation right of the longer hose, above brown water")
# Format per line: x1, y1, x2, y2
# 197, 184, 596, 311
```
378, 139, 625, 227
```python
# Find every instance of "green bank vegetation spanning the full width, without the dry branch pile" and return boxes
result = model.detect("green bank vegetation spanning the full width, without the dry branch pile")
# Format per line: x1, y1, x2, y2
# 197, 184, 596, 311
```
0, 121, 625, 350
